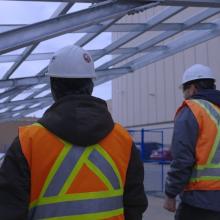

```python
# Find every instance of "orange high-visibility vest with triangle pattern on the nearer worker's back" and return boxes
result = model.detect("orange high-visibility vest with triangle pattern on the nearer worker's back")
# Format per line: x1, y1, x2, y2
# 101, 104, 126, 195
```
19, 124, 132, 220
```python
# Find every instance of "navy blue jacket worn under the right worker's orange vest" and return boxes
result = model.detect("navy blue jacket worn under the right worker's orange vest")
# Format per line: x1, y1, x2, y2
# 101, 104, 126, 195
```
165, 90, 220, 211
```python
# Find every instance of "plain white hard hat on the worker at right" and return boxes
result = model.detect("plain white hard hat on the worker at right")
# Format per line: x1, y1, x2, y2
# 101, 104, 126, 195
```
182, 64, 215, 85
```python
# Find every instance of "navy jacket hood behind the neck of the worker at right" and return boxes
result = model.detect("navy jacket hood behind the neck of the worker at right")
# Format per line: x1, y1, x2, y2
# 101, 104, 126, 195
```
191, 89, 220, 107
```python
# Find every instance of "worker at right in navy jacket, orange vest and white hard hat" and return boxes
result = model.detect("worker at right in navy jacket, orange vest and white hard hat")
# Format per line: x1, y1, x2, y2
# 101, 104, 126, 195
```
164, 64, 220, 220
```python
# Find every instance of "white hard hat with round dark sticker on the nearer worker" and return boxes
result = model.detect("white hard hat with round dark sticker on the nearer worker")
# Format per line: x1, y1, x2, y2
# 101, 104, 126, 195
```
46, 45, 96, 78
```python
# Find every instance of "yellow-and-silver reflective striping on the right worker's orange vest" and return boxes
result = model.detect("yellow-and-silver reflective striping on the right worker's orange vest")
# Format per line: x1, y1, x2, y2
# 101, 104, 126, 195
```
190, 100, 220, 182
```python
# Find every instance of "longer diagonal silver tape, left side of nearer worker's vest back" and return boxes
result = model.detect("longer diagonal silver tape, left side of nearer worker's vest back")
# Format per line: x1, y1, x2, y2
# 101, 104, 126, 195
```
43, 145, 86, 197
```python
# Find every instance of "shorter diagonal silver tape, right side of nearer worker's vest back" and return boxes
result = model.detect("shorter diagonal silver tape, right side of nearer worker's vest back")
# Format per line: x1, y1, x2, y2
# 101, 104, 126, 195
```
88, 150, 120, 189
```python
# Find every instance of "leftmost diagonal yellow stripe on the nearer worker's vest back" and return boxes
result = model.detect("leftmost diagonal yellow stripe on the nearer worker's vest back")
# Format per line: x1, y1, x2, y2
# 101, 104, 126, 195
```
29, 142, 72, 208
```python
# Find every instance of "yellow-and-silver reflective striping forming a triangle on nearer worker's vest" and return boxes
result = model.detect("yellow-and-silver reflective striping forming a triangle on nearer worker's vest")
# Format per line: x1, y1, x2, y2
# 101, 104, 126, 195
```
29, 124, 123, 220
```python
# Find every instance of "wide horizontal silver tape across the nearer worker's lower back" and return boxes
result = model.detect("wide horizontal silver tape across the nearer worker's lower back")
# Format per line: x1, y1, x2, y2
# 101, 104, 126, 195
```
29, 196, 123, 220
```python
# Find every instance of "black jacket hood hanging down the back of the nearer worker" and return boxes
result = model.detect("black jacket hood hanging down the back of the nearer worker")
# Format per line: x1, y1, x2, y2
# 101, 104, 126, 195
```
39, 95, 114, 146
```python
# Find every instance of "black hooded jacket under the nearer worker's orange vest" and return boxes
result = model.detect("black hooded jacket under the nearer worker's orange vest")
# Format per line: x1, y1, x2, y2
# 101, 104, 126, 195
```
0, 95, 147, 220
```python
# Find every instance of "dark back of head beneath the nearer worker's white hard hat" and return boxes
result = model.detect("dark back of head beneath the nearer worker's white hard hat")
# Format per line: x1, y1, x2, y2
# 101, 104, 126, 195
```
50, 77, 94, 101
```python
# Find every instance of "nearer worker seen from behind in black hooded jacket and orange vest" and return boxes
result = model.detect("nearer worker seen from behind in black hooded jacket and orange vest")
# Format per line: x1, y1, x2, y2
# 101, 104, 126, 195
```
0, 46, 147, 220
